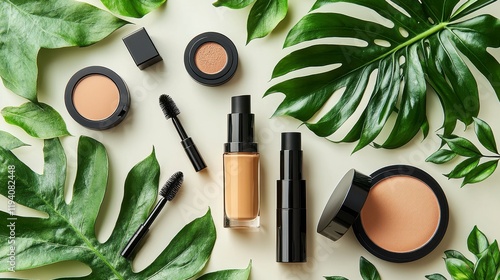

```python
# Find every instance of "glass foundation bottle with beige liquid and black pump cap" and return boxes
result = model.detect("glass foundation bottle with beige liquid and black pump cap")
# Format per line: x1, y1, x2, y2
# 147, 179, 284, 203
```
223, 95, 260, 228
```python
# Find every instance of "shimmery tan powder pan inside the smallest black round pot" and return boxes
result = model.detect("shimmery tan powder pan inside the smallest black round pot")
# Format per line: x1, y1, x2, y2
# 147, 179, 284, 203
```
195, 42, 227, 75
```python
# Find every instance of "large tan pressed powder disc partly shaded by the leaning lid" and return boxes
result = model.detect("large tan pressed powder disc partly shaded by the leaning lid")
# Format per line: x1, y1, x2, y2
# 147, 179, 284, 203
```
361, 176, 440, 253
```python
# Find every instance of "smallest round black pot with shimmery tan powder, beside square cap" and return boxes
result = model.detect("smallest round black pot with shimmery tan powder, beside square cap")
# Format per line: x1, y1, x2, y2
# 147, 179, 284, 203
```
184, 32, 238, 86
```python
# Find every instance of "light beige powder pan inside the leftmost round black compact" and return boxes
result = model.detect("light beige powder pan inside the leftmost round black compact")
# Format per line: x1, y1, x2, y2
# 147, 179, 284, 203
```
73, 74, 120, 121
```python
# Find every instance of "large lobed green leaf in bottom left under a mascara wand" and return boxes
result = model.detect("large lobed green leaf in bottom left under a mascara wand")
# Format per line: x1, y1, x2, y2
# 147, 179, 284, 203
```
0, 137, 216, 280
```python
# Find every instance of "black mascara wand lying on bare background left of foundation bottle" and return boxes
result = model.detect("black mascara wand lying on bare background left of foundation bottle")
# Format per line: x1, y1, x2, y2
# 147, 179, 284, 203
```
160, 94, 207, 172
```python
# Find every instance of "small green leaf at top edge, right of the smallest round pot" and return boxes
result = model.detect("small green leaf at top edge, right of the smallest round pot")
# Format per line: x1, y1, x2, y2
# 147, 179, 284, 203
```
247, 0, 288, 44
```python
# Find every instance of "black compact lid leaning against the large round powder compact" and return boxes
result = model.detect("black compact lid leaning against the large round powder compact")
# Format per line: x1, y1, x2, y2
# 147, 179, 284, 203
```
317, 169, 372, 241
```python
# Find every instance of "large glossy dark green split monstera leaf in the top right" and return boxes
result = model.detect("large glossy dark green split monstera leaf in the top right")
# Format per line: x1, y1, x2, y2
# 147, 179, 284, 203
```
265, 0, 500, 151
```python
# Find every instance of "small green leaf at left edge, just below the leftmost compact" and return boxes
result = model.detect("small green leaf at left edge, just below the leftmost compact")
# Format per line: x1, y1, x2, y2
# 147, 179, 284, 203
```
2, 102, 70, 139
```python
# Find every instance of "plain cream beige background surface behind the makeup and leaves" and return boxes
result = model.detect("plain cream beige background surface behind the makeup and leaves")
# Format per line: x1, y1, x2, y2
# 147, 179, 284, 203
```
0, 0, 500, 279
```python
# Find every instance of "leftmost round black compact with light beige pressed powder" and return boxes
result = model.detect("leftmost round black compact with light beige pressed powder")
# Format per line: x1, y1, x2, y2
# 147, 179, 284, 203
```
64, 66, 130, 130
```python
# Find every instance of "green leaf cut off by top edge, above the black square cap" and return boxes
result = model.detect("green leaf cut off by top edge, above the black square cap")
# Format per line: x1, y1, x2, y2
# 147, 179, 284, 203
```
101, 0, 167, 18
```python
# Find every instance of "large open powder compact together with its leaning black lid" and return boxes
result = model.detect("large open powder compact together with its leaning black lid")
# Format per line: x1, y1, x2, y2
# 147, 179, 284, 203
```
317, 165, 449, 263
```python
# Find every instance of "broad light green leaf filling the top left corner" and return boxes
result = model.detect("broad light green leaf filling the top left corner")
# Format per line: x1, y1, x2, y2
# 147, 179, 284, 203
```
0, 0, 128, 102
